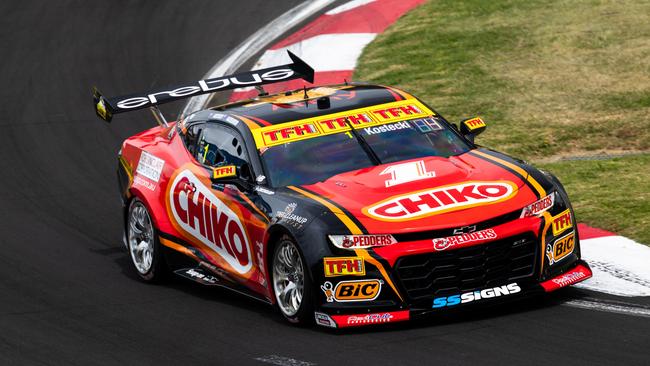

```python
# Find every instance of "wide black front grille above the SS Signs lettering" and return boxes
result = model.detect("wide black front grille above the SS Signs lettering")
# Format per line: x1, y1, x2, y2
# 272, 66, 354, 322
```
395, 233, 538, 301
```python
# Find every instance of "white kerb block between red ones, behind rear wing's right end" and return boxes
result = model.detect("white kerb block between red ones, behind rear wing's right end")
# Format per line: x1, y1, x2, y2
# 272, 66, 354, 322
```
253, 33, 377, 72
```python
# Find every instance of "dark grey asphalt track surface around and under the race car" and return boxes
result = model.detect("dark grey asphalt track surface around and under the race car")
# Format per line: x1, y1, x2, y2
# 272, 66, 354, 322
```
0, 0, 650, 365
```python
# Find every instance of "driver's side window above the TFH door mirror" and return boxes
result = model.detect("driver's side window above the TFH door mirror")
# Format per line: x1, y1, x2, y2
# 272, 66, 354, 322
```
195, 124, 251, 177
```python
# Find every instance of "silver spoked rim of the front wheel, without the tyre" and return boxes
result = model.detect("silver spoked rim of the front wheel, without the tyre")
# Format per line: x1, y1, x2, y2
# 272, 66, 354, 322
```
273, 241, 305, 316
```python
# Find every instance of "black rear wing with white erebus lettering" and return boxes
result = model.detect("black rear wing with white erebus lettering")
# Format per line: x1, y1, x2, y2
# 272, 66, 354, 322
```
93, 51, 314, 122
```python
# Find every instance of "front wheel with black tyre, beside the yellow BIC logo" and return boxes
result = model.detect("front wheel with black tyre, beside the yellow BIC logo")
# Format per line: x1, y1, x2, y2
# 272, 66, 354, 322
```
271, 235, 314, 325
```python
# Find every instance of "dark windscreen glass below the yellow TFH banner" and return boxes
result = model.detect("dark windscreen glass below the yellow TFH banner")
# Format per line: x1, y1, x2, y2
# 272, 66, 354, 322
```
260, 117, 470, 187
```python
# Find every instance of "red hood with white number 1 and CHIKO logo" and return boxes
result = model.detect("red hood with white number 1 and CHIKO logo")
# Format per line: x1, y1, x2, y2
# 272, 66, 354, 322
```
305, 153, 537, 233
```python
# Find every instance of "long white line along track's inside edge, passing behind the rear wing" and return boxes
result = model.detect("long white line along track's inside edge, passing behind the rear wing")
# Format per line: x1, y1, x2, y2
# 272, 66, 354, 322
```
181, 0, 335, 115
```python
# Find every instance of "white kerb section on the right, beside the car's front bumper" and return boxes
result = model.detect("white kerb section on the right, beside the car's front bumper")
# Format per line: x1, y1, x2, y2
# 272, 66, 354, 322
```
575, 236, 650, 296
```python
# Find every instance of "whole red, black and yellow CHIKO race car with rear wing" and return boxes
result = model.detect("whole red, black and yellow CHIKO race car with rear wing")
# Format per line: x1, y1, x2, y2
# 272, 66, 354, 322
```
94, 54, 591, 327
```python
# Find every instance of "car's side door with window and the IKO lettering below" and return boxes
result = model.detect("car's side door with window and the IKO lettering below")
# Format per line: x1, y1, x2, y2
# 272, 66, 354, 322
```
187, 122, 269, 293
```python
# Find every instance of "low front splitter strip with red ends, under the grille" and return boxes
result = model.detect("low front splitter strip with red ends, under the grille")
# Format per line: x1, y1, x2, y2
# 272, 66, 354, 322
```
314, 260, 592, 328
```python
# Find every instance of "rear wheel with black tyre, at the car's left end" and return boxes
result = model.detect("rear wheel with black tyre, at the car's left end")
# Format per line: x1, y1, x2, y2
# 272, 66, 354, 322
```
125, 198, 167, 283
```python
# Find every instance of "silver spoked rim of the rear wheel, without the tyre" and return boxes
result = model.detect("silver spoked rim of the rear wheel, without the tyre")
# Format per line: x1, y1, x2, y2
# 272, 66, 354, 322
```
128, 202, 154, 274
